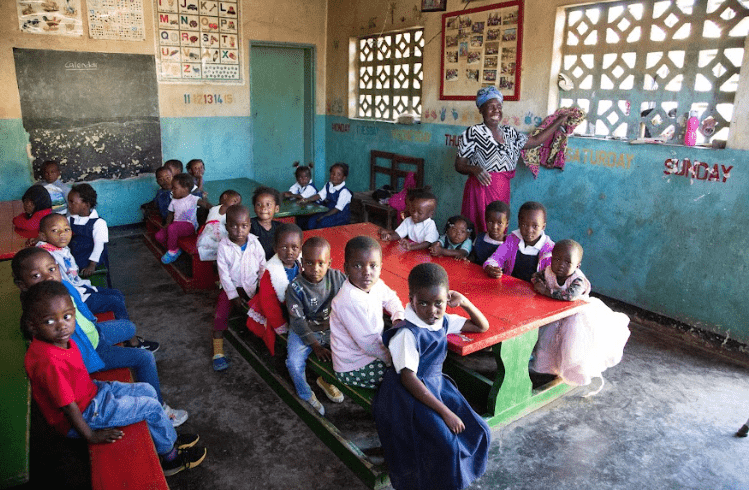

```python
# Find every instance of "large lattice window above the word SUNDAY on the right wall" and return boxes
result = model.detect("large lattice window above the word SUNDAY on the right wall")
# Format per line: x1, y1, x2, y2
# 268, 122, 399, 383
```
559, 0, 749, 144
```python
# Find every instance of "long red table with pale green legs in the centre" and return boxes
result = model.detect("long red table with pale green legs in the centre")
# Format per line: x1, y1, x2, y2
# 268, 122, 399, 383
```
305, 223, 585, 425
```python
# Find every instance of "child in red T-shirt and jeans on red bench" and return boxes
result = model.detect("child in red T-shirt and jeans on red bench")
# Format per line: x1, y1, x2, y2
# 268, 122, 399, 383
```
21, 281, 206, 476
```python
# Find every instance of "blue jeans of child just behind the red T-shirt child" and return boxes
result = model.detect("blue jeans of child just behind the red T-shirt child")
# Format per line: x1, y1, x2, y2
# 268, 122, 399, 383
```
96, 320, 164, 404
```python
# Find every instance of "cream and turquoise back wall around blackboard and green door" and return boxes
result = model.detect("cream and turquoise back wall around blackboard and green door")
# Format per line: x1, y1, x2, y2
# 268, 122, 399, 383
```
0, 0, 327, 225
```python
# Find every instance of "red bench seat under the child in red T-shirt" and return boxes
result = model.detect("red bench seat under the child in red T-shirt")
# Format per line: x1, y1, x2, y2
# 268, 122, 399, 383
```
88, 368, 169, 490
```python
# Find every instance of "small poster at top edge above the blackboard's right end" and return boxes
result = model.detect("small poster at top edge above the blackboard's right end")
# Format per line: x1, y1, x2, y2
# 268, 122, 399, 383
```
86, 0, 146, 41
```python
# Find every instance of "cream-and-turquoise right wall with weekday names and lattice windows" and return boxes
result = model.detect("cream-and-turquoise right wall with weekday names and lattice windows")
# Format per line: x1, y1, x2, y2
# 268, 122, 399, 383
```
326, 0, 749, 343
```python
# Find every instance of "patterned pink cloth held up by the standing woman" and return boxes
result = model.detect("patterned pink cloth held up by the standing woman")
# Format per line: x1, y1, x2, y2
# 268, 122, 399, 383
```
522, 107, 587, 178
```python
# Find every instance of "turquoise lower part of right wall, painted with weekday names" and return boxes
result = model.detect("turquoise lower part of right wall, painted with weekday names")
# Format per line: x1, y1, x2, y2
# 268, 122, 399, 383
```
326, 116, 749, 343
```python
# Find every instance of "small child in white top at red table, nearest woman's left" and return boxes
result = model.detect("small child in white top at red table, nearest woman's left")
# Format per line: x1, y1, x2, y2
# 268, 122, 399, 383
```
380, 190, 440, 250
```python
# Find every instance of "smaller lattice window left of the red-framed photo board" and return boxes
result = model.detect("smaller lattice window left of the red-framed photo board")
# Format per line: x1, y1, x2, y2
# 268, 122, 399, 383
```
356, 29, 424, 121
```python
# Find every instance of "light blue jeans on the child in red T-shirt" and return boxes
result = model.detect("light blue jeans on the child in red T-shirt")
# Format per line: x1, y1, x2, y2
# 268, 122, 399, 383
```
68, 380, 177, 455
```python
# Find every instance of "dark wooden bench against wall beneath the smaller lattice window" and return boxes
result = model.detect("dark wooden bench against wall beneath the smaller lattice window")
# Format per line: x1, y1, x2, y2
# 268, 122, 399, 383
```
351, 150, 424, 230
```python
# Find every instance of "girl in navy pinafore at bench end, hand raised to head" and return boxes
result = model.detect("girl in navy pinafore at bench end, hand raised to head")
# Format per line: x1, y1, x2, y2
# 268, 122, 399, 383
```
372, 263, 491, 490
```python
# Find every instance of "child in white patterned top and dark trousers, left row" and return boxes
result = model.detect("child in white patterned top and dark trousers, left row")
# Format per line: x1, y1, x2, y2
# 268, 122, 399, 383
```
36, 213, 130, 320
